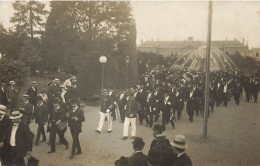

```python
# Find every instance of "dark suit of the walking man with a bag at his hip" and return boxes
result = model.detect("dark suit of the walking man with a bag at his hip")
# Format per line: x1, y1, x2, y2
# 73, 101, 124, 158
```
48, 108, 68, 152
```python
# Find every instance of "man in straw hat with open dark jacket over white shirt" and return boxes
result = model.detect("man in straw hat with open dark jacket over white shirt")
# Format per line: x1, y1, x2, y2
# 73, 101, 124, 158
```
5, 111, 33, 166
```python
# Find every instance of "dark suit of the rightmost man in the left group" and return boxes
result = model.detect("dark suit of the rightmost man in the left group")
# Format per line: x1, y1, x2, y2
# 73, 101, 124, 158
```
68, 108, 85, 155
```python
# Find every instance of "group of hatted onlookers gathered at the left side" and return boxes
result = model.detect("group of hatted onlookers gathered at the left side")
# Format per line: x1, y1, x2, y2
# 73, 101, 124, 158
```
0, 75, 85, 166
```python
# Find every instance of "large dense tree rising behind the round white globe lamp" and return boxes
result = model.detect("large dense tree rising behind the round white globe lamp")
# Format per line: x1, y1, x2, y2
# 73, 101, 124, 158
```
42, 1, 138, 96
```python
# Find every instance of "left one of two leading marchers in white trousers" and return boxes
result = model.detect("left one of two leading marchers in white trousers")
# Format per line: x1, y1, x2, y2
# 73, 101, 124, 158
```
95, 89, 114, 133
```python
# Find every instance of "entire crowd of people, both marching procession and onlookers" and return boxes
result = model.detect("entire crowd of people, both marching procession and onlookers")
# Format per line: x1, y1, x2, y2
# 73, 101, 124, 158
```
0, 59, 259, 166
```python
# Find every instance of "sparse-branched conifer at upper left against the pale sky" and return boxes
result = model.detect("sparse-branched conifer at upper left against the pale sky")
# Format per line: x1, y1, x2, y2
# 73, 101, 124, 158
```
10, 1, 48, 39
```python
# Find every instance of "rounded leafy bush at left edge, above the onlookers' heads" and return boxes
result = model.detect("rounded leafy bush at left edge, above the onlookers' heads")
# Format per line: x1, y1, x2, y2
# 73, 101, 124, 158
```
0, 57, 28, 86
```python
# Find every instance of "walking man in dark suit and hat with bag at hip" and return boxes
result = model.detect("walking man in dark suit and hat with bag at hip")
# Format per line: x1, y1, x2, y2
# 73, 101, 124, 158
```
48, 99, 69, 153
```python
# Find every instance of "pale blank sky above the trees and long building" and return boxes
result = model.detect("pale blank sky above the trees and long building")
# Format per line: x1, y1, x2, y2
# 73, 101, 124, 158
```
0, 1, 260, 48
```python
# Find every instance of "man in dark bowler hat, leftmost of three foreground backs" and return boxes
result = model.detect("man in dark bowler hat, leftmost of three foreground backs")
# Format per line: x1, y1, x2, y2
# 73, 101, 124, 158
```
128, 137, 148, 166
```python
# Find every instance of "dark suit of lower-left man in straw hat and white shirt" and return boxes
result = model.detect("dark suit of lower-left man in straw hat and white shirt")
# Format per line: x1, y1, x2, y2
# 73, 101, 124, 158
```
5, 122, 33, 166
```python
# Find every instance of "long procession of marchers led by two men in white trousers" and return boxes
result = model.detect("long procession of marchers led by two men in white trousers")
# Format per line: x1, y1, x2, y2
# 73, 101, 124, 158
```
95, 65, 259, 140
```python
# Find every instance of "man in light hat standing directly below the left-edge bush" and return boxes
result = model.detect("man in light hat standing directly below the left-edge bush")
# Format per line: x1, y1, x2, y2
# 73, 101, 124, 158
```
6, 81, 19, 112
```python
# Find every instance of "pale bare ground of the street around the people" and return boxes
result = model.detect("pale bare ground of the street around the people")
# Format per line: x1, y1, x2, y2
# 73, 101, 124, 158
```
31, 94, 260, 166
